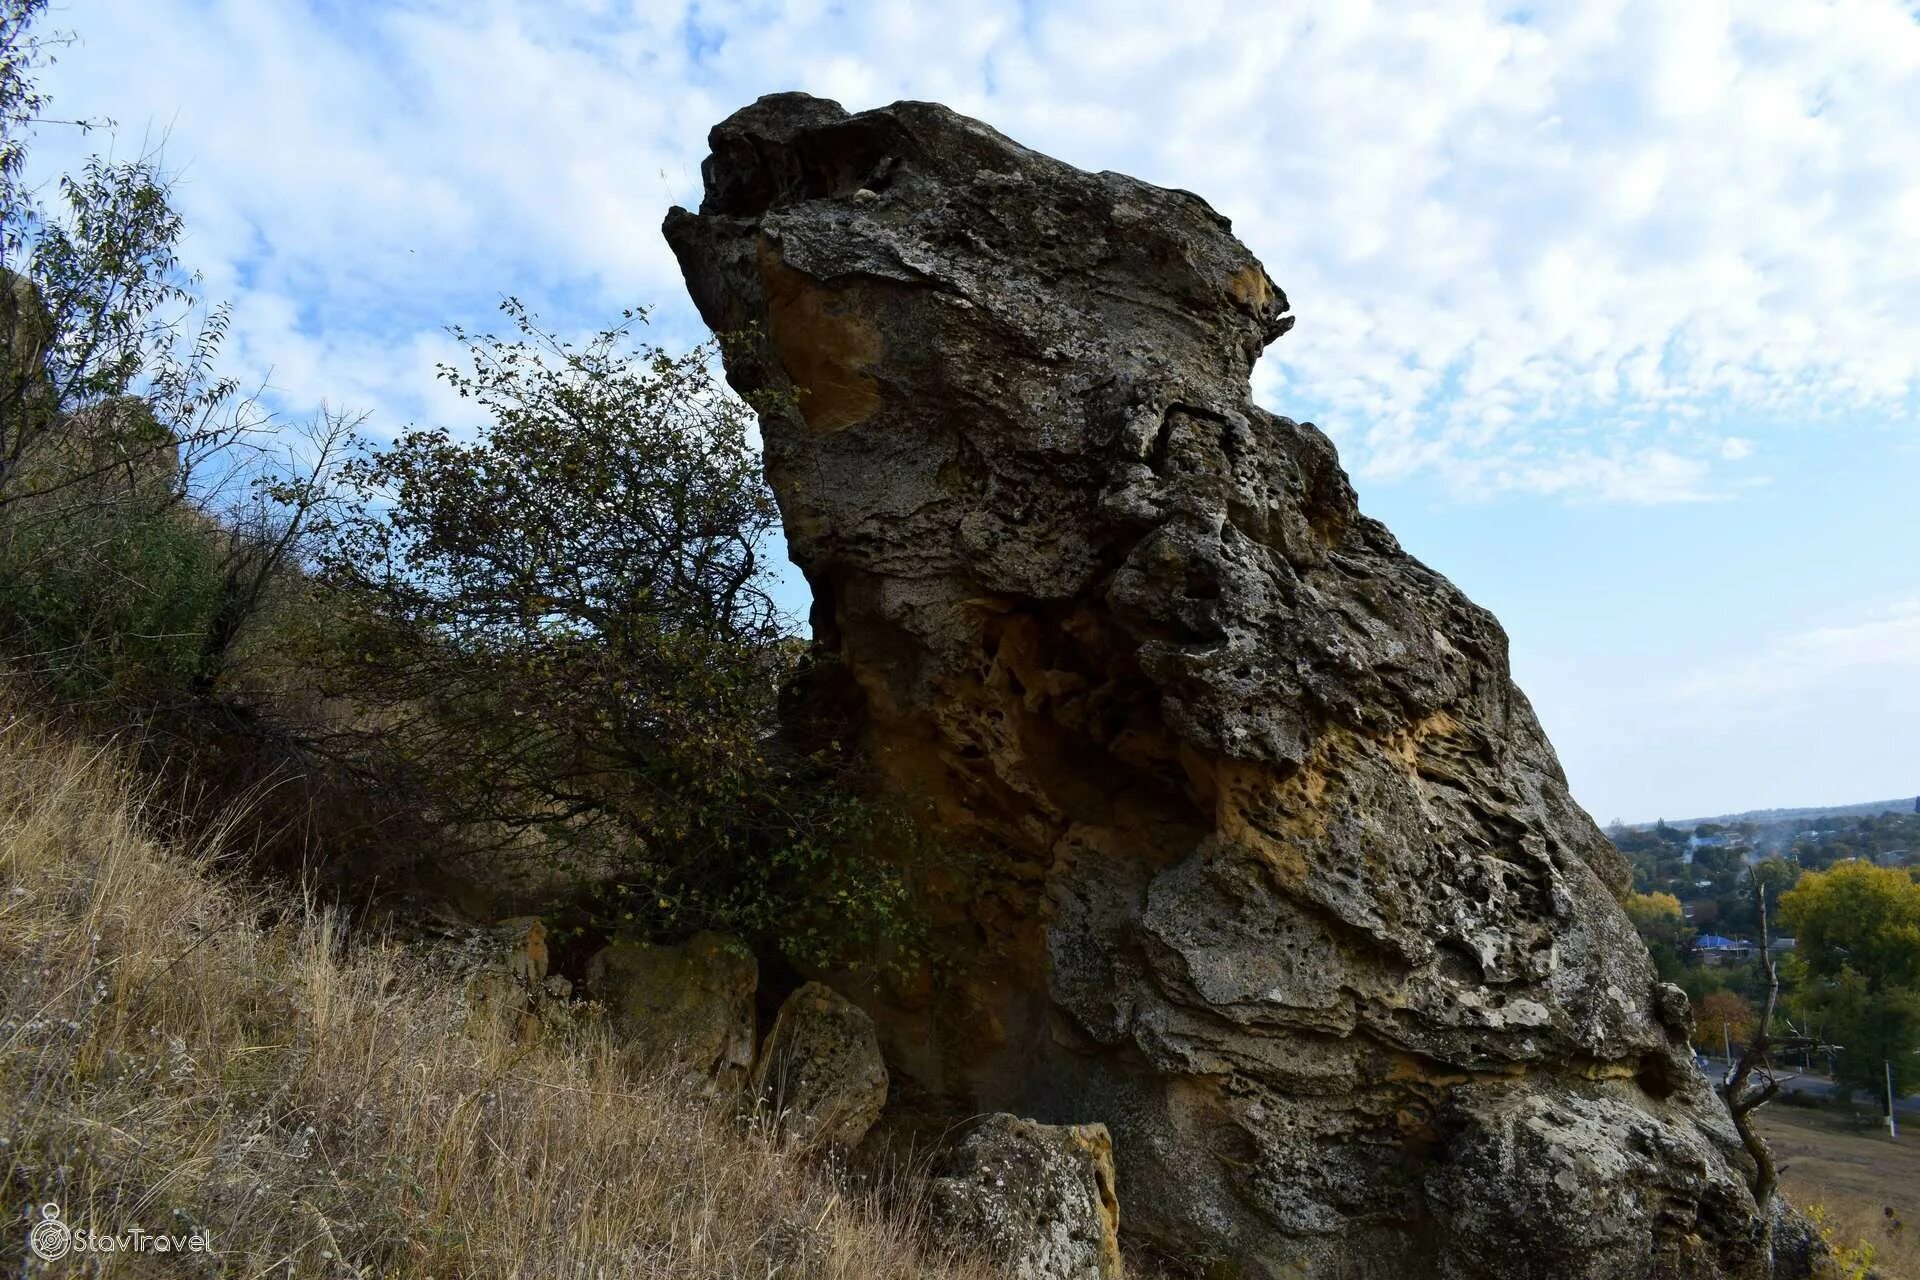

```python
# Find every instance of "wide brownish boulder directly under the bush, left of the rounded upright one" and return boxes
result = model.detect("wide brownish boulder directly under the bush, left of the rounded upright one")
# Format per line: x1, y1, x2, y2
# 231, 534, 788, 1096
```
586, 933, 760, 1086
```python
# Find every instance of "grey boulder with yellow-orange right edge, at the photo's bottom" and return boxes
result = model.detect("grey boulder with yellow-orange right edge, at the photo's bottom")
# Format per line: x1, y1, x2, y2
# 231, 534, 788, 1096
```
931, 1115, 1121, 1280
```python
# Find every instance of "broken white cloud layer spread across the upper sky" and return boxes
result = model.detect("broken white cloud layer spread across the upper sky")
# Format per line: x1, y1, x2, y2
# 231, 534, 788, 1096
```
26, 0, 1920, 485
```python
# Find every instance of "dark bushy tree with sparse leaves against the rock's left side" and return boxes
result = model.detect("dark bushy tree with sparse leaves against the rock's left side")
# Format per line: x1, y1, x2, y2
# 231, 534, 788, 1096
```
326, 299, 908, 956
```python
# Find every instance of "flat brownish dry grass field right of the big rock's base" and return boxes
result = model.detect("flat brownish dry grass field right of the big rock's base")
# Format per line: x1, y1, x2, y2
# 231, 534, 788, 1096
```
1759, 1105, 1920, 1280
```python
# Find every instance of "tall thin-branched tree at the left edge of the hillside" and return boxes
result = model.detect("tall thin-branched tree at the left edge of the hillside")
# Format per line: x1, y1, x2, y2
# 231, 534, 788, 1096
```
0, 0, 336, 708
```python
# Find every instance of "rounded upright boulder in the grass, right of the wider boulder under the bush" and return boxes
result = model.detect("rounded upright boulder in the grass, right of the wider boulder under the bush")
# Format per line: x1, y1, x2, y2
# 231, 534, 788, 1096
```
753, 983, 887, 1151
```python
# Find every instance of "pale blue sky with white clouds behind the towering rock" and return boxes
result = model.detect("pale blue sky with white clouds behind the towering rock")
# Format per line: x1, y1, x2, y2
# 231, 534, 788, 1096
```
36, 0, 1920, 821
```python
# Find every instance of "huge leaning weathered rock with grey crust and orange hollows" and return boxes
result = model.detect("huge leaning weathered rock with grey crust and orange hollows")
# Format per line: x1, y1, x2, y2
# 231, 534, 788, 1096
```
666, 94, 1766, 1280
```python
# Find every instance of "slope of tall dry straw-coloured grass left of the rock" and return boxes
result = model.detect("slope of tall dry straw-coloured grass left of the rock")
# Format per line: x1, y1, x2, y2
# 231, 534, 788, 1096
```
0, 720, 985, 1280
